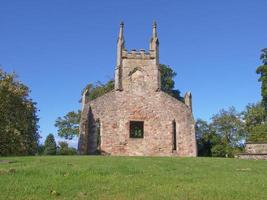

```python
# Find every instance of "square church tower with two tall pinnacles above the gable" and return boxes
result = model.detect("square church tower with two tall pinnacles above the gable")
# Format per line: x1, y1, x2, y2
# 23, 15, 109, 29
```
115, 22, 160, 94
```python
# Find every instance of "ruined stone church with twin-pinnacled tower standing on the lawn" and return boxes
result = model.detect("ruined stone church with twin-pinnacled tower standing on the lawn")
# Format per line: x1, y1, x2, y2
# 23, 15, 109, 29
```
78, 23, 197, 156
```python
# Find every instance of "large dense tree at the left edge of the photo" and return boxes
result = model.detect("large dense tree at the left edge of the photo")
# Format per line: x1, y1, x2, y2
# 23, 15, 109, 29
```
0, 69, 40, 156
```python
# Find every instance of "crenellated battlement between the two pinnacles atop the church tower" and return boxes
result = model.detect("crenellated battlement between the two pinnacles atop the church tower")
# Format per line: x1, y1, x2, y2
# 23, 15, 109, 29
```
122, 49, 156, 60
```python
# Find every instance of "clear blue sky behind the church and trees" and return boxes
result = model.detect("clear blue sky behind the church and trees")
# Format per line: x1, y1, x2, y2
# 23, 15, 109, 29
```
0, 0, 267, 144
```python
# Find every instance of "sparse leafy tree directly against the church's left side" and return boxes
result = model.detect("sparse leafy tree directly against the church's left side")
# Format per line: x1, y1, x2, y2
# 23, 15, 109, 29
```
55, 110, 81, 140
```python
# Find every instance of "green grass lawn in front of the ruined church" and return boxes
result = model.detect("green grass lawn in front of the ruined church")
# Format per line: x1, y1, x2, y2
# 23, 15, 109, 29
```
0, 156, 267, 200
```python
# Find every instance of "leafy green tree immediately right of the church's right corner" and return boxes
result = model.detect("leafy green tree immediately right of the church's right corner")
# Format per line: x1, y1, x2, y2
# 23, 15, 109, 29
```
196, 107, 247, 157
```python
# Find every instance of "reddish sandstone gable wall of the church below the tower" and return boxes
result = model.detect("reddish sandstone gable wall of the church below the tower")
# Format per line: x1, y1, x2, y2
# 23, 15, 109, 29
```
80, 91, 196, 156
